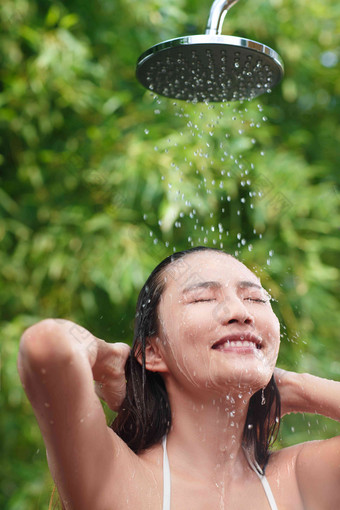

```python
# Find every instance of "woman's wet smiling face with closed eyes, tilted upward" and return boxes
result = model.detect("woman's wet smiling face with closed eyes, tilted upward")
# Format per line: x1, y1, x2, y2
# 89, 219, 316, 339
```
158, 251, 280, 395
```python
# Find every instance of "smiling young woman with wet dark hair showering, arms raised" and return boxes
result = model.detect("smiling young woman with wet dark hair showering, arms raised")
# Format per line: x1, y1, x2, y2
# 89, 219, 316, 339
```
18, 248, 340, 510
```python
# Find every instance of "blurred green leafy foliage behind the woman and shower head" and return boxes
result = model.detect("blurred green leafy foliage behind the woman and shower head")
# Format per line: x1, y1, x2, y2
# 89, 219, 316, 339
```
0, 0, 340, 510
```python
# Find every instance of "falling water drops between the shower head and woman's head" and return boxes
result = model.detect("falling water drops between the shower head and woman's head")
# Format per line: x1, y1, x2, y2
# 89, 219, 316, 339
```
143, 94, 274, 264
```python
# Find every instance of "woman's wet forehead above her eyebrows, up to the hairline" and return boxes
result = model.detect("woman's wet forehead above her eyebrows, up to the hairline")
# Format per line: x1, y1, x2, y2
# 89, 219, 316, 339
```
163, 251, 261, 293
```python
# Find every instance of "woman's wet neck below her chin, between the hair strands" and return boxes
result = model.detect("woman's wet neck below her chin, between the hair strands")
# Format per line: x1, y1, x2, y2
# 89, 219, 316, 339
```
168, 388, 251, 481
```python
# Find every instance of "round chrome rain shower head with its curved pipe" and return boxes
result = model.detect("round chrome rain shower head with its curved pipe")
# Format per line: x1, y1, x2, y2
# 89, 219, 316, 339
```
136, 0, 283, 102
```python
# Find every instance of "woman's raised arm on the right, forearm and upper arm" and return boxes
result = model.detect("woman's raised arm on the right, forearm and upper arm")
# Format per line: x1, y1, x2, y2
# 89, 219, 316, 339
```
275, 369, 340, 510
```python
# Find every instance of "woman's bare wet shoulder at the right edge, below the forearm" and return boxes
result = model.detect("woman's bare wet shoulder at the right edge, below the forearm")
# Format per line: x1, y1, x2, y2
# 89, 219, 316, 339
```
266, 437, 340, 510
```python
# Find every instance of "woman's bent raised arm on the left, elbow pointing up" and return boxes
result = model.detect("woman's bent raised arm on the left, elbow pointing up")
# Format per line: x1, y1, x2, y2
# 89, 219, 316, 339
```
18, 319, 134, 510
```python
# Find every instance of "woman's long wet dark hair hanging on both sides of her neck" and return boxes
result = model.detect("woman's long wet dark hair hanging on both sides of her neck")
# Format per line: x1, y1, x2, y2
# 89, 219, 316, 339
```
111, 246, 281, 471
